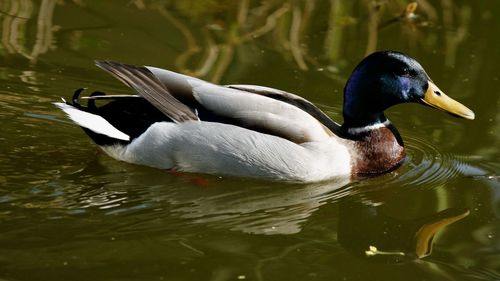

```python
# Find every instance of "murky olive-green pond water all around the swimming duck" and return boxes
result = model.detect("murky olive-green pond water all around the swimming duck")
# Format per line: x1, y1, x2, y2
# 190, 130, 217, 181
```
0, 0, 500, 281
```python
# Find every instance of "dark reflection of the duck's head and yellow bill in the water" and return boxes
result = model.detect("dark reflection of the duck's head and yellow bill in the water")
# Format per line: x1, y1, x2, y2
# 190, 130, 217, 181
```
337, 199, 469, 263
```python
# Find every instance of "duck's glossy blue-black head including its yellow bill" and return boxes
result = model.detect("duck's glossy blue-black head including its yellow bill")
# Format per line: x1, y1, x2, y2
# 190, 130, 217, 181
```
343, 51, 474, 128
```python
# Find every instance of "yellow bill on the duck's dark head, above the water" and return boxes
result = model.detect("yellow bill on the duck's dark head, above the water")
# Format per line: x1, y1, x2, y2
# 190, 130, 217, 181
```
421, 81, 476, 120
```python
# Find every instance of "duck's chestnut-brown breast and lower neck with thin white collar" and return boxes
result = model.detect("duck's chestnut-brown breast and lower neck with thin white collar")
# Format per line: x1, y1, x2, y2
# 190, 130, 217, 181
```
342, 117, 405, 175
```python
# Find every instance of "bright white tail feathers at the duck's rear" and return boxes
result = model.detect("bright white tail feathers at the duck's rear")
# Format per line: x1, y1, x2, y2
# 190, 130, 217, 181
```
54, 102, 130, 141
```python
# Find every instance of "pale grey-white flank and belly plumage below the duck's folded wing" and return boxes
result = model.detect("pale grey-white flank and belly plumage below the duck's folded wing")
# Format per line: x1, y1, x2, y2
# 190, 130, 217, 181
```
102, 121, 351, 182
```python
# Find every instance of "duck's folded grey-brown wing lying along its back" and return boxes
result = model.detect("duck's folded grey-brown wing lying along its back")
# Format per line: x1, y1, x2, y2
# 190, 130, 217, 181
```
97, 61, 334, 143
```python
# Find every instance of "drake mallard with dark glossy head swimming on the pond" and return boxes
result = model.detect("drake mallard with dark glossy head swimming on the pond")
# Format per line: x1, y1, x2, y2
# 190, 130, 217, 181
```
55, 51, 474, 182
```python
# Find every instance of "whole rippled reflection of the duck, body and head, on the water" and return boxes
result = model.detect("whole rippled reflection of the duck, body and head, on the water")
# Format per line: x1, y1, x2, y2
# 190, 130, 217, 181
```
58, 156, 469, 263
